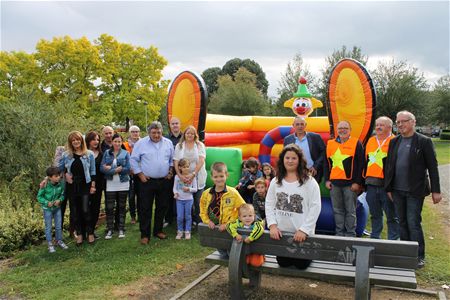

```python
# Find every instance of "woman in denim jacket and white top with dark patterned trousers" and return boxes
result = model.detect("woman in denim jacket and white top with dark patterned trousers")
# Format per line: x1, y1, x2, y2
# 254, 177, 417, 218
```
100, 133, 130, 240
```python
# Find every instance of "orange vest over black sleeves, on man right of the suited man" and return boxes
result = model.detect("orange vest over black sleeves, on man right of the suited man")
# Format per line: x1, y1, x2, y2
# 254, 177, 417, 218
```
327, 137, 358, 180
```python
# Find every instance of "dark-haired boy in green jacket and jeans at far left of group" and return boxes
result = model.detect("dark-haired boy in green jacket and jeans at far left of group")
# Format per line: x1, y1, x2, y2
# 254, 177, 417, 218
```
37, 167, 68, 253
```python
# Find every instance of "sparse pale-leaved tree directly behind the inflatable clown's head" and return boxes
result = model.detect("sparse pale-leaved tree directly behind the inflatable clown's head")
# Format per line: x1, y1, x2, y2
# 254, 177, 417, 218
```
272, 53, 318, 116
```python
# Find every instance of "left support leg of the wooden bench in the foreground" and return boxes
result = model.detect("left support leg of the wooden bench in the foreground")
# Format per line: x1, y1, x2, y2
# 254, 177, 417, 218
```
228, 240, 246, 300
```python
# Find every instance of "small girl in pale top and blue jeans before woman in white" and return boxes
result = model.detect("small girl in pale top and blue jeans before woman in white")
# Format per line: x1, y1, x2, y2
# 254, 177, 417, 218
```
173, 158, 197, 240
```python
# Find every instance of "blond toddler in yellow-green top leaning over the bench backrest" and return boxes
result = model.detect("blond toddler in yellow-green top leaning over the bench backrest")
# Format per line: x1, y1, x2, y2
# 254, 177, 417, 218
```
227, 204, 265, 267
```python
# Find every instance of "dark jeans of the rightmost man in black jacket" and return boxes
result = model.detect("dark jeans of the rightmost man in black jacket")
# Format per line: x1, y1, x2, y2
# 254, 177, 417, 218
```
392, 190, 425, 259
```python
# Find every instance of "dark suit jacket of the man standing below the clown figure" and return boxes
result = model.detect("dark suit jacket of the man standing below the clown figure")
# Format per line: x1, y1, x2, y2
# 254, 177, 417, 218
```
283, 132, 325, 183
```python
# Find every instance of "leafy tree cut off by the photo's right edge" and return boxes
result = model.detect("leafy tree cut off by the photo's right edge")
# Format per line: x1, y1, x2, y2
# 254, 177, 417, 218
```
430, 75, 450, 127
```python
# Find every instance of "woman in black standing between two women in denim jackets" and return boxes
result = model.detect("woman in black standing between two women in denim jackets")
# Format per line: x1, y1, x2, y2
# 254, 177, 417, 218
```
85, 131, 105, 238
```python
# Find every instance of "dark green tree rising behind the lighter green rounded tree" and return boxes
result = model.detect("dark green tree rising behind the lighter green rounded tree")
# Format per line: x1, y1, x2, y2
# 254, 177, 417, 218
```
222, 58, 269, 96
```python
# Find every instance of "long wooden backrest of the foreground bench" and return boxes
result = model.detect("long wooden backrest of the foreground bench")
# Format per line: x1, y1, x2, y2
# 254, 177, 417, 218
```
198, 224, 418, 269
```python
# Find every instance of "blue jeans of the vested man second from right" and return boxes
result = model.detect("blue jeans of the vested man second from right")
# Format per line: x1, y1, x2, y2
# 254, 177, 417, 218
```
366, 184, 400, 240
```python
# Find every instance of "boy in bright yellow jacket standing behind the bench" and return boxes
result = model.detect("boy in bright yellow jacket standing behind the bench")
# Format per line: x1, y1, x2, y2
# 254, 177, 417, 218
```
200, 162, 245, 257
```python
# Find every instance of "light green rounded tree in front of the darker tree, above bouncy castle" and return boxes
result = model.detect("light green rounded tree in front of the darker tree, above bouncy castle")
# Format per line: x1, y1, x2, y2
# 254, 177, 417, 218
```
208, 67, 269, 116
